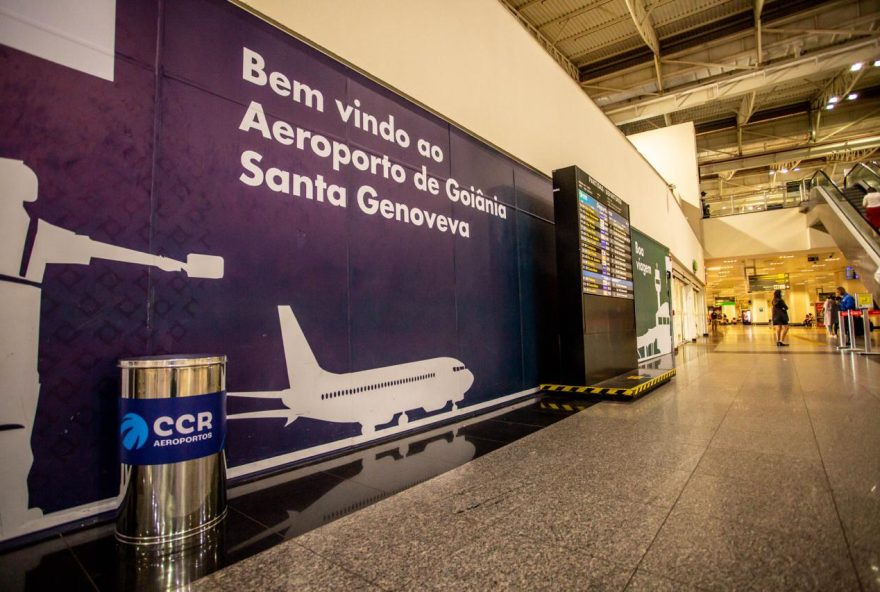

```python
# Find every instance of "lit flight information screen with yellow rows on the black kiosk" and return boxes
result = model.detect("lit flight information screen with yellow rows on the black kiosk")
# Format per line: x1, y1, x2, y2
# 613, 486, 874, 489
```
578, 179, 633, 299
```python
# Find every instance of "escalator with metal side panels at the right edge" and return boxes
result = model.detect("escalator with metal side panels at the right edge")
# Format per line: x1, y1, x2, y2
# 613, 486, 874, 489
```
800, 164, 880, 302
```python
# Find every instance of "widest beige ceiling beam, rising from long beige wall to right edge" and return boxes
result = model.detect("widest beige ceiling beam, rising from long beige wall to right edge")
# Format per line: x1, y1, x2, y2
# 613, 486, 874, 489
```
605, 39, 880, 125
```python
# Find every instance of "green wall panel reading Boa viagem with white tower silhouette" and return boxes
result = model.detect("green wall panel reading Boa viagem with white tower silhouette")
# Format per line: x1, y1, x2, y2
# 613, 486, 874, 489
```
630, 227, 672, 361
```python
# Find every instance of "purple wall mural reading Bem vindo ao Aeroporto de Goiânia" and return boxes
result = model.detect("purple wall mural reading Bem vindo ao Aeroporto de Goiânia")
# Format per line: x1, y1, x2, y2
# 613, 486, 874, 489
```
0, 0, 558, 538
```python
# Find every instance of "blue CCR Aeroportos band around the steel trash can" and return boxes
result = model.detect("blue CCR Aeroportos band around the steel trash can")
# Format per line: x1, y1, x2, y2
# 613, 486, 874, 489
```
119, 391, 226, 465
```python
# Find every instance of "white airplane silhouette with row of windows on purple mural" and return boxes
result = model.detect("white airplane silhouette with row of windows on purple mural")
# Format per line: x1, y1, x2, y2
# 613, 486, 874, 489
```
227, 306, 474, 435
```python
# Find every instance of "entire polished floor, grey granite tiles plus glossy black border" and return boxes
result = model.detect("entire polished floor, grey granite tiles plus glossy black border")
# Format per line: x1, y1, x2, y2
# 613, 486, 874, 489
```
0, 327, 880, 591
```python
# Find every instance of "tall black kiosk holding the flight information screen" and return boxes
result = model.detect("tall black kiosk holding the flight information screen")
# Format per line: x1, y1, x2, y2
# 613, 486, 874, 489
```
553, 166, 638, 385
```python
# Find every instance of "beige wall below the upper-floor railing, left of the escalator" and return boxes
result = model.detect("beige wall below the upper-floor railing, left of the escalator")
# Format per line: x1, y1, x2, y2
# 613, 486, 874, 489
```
703, 208, 837, 259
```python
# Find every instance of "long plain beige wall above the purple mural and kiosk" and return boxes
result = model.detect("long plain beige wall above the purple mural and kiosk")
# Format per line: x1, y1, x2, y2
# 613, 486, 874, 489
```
242, 0, 704, 279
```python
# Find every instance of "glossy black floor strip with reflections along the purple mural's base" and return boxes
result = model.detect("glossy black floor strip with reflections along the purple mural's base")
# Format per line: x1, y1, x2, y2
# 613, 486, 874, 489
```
0, 390, 591, 591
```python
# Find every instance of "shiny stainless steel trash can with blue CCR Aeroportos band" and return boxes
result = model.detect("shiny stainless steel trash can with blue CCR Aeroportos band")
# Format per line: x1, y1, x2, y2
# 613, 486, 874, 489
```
116, 355, 226, 546
